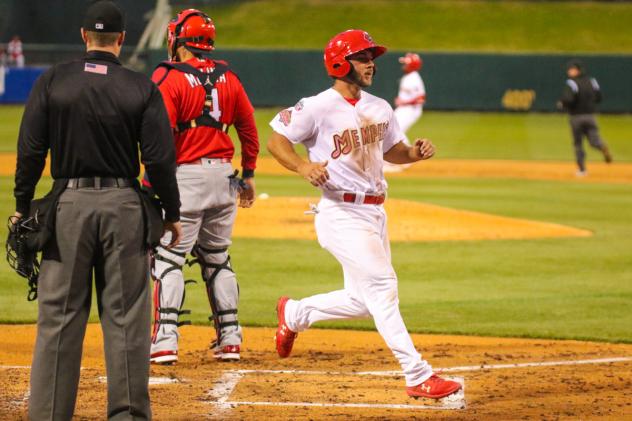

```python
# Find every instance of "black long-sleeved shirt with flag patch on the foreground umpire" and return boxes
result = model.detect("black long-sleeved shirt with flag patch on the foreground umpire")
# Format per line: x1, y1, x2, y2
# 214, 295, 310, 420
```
14, 51, 180, 222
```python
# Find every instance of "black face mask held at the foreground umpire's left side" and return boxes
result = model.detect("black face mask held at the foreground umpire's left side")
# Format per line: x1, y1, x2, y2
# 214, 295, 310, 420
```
6, 216, 39, 301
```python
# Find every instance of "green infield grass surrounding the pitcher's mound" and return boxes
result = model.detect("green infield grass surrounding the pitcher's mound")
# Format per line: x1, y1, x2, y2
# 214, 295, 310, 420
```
0, 176, 632, 342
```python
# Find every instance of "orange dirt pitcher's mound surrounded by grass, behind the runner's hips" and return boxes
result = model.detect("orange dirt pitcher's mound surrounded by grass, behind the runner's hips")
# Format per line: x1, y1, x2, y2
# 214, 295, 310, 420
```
233, 196, 592, 242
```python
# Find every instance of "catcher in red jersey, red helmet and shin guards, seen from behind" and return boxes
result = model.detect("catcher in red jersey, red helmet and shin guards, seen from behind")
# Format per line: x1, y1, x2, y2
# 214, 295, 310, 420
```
150, 9, 259, 364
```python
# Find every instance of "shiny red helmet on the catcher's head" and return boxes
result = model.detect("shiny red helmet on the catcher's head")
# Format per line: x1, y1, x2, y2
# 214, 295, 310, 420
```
167, 9, 215, 61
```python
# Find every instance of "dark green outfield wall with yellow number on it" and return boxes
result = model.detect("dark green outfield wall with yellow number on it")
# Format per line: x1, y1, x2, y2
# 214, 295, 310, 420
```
154, 50, 632, 112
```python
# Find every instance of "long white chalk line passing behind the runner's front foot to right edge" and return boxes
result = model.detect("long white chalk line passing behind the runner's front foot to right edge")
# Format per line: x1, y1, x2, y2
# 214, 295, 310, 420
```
233, 357, 632, 377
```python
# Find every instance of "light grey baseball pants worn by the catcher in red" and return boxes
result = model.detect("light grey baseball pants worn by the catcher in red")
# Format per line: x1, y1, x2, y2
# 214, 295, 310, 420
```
151, 158, 242, 354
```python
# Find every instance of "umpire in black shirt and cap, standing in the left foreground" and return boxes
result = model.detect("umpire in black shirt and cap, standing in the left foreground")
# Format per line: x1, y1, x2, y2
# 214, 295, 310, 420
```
15, 1, 181, 420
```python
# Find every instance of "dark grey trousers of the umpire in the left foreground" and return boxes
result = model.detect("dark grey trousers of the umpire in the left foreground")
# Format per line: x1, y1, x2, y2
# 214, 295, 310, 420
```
29, 188, 151, 420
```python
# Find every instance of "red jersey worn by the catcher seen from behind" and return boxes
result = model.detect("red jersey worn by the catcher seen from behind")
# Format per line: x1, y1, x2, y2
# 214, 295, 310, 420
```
152, 58, 259, 175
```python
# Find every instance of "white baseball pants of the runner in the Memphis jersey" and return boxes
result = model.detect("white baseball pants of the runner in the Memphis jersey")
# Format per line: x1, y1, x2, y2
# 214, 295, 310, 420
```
285, 198, 432, 386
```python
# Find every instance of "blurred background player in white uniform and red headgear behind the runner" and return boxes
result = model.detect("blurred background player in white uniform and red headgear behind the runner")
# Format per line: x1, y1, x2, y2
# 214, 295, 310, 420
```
384, 53, 426, 172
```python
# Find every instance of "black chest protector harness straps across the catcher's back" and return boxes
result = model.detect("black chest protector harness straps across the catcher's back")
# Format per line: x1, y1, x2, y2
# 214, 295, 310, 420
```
157, 61, 230, 132
